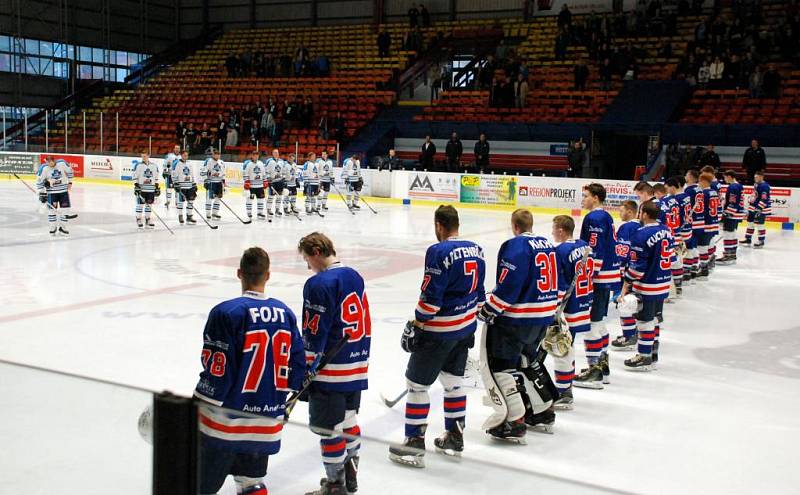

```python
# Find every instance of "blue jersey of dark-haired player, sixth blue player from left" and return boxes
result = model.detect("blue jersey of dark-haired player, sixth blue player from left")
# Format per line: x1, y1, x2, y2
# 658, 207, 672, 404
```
581, 208, 620, 287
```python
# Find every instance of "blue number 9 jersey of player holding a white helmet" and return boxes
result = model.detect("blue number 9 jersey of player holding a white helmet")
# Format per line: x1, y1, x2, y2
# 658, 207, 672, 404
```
628, 223, 674, 300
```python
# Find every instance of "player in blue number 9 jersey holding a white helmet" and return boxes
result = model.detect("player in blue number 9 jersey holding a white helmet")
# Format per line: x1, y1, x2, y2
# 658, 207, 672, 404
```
619, 202, 674, 371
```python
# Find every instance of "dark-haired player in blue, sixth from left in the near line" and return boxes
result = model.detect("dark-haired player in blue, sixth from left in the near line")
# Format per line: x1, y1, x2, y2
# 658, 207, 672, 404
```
573, 183, 620, 389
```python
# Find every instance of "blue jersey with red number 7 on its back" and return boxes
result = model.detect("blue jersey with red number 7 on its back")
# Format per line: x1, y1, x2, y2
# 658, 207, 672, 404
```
417, 238, 486, 340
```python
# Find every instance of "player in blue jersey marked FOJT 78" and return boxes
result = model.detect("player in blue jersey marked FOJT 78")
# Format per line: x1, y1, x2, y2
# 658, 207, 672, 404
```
194, 247, 306, 495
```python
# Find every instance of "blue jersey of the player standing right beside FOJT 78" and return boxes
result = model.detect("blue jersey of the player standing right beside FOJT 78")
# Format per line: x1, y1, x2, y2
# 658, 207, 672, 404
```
303, 262, 372, 392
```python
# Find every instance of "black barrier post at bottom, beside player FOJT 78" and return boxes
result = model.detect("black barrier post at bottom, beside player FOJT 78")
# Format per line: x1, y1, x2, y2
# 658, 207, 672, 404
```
153, 392, 198, 495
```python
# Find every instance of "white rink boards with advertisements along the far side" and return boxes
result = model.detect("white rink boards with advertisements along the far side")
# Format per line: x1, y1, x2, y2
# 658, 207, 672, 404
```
0, 152, 800, 230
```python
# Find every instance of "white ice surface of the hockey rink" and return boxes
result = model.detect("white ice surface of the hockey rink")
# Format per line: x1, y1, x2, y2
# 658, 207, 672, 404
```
0, 177, 800, 495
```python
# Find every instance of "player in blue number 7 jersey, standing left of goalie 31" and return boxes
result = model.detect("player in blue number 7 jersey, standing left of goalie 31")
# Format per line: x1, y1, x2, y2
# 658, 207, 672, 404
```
389, 205, 486, 467
